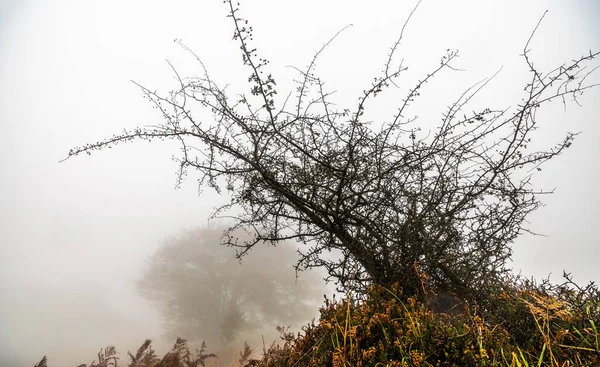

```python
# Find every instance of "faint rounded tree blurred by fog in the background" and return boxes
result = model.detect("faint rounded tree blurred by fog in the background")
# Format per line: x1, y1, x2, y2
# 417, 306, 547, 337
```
137, 228, 324, 348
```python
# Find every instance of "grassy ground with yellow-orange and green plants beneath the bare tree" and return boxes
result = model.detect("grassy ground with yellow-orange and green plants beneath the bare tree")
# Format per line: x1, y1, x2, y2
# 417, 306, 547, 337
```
36, 275, 600, 367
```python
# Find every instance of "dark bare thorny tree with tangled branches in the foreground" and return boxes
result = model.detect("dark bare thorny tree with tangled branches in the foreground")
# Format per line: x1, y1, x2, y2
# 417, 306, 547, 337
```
63, 1, 598, 297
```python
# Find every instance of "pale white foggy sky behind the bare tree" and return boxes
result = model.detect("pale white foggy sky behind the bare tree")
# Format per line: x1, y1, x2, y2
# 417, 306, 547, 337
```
0, 0, 600, 366
